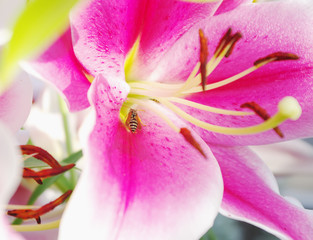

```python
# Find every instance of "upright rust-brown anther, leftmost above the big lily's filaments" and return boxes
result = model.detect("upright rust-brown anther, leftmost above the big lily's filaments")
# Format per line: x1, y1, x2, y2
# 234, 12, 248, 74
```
199, 29, 208, 91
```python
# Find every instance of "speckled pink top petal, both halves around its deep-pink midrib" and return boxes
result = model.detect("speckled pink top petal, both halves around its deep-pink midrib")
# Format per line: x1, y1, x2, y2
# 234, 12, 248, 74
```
71, 0, 220, 81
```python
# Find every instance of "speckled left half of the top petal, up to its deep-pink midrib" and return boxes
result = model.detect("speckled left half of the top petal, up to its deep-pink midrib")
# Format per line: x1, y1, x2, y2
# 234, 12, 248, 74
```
71, 0, 146, 76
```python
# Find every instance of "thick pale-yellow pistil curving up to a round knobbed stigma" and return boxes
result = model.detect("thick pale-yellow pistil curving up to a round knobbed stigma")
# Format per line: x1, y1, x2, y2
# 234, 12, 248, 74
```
158, 97, 301, 135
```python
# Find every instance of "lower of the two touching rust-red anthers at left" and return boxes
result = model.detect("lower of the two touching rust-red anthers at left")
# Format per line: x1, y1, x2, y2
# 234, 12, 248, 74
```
23, 163, 75, 184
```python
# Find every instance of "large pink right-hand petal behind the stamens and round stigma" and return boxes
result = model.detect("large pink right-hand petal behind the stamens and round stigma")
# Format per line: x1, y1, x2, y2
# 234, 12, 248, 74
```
147, 1, 313, 145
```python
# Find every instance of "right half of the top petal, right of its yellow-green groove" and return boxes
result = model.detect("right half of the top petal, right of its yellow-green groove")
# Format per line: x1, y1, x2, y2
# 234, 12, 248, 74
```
131, 0, 222, 80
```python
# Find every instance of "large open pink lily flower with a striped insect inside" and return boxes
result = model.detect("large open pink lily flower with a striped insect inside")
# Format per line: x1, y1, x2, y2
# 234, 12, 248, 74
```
28, 0, 313, 239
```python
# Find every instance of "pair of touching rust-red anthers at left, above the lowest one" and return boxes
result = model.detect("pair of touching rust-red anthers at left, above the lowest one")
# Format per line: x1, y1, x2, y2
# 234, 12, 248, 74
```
20, 145, 75, 184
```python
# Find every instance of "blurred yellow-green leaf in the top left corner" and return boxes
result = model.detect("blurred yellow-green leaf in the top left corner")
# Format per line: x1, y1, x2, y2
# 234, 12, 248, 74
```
0, 0, 79, 90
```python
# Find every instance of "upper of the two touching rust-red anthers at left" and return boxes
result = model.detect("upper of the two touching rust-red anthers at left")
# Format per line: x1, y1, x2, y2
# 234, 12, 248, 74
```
20, 145, 61, 168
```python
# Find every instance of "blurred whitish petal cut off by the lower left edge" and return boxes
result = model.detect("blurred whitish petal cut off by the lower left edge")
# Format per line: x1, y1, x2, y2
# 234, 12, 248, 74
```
0, 123, 22, 240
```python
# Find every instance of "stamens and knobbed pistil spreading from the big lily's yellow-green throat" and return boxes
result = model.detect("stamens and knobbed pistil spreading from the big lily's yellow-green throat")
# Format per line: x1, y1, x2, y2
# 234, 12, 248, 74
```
120, 29, 301, 140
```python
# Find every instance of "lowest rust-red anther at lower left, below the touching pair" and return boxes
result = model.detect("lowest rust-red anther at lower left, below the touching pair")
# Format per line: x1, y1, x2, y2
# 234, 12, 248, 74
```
7, 190, 73, 224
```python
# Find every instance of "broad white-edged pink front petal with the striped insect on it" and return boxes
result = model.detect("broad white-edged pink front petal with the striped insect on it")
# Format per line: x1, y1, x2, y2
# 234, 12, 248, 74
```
60, 76, 222, 240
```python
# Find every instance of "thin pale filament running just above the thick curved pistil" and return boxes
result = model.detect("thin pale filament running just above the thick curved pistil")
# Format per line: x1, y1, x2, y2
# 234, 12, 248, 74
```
166, 97, 254, 116
